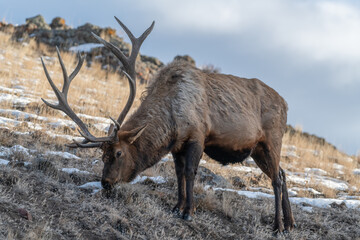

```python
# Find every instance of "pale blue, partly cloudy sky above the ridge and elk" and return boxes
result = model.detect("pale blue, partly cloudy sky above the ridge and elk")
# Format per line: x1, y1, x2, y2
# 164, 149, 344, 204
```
0, 0, 360, 154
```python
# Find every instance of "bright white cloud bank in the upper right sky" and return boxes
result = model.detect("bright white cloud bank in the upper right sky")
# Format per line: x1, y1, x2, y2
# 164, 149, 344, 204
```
134, 0, 360, 87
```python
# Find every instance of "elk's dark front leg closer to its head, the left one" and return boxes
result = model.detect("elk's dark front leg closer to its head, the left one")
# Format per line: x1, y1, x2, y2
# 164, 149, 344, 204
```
172, 153, 186, 214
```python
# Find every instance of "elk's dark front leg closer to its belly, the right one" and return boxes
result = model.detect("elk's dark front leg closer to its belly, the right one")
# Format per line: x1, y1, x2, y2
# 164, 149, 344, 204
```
182, 142, 203, 221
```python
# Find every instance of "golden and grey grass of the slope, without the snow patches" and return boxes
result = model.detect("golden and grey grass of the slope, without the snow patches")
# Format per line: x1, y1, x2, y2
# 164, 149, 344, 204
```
0, 33, 360, 239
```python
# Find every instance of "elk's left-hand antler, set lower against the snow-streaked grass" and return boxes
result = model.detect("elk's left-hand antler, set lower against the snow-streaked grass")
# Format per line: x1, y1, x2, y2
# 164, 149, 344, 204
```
41, 47, 119, 148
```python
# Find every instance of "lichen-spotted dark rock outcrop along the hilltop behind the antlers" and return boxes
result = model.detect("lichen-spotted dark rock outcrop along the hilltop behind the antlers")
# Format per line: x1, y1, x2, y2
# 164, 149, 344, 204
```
0, 15, 163, 84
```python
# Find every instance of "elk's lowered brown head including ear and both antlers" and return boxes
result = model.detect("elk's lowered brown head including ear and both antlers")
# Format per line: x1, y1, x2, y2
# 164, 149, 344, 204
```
41, 17, 155, 189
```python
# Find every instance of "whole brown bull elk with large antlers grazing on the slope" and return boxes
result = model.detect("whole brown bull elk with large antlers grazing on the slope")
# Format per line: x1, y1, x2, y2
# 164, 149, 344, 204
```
41, 17, 295, 232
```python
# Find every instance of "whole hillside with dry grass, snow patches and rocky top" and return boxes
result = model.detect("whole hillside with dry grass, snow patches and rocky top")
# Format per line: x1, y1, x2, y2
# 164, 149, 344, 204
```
0, 15, 360, 239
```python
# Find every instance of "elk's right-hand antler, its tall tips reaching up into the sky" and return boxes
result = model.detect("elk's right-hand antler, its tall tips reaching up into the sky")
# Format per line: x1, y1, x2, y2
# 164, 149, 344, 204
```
92, 17, 155, 125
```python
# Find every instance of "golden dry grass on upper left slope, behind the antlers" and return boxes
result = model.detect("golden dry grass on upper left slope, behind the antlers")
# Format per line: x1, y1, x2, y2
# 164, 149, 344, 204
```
0, 33, 144, 141
